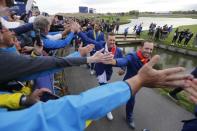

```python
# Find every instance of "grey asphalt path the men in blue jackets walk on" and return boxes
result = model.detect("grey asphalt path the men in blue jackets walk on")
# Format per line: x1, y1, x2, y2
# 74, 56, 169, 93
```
65, 66, 193, 131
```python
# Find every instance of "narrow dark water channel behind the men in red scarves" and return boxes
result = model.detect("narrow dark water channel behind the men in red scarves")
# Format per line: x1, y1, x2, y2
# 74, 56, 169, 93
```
120, 45, 197, 73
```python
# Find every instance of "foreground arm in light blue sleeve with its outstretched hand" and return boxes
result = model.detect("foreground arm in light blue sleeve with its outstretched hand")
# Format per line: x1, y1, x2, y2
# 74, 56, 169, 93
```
0, 56, 191, 131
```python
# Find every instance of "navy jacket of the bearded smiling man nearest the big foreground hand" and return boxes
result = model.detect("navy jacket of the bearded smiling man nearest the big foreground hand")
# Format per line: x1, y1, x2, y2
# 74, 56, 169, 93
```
116, 52, 143, 80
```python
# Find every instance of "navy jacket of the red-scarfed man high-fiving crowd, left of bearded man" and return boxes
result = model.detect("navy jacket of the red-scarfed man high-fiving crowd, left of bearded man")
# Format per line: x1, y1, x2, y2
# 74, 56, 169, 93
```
78, 32, 123, 81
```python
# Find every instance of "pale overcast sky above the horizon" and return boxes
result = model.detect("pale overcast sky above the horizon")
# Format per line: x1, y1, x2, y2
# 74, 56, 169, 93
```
35, 0, 197, 14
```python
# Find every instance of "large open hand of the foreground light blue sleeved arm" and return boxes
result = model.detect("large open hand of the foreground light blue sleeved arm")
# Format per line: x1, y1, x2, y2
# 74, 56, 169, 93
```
127, 55, 192, 93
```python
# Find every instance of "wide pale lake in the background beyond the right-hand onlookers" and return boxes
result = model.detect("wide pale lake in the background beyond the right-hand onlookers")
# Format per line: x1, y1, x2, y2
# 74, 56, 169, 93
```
119, 17, 197, 33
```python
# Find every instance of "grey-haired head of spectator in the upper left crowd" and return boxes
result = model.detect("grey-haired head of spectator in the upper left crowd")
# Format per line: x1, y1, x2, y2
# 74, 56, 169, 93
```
33, 15, 50, 33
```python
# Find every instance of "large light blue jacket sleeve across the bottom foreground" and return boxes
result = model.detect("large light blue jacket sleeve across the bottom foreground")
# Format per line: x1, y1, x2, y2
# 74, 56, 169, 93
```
0, 81, 132, 131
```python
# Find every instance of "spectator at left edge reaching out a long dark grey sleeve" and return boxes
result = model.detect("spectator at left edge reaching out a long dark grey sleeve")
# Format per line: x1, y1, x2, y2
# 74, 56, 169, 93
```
0, 28, 114, 84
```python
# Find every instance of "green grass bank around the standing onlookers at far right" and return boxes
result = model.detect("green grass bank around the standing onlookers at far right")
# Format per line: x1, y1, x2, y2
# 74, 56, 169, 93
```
141, 25, 197, 51
